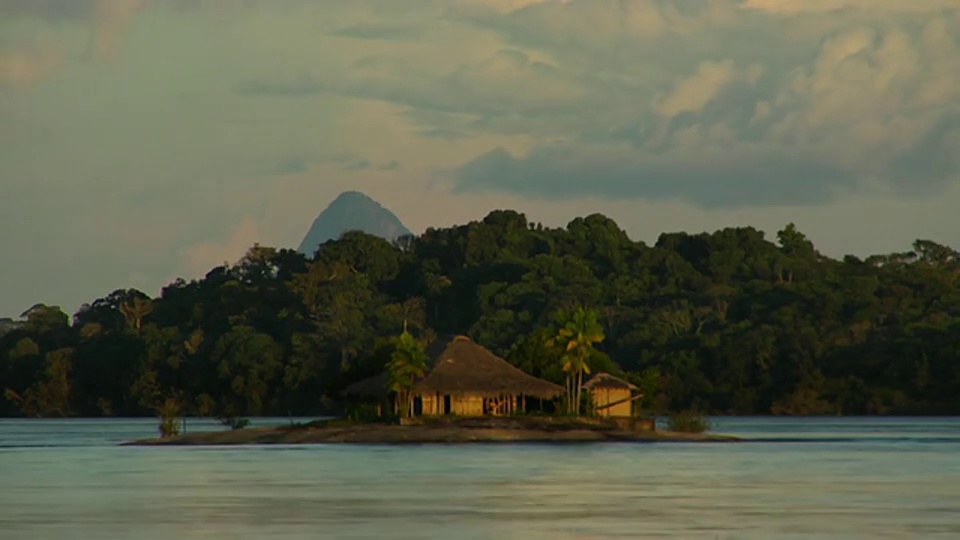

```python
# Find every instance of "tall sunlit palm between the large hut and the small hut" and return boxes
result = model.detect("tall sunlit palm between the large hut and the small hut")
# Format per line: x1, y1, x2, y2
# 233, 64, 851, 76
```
547, 307, 605, 415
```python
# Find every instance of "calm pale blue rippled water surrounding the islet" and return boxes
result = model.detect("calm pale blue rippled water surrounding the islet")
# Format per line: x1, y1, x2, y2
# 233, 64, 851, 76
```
0, 418, 960, 540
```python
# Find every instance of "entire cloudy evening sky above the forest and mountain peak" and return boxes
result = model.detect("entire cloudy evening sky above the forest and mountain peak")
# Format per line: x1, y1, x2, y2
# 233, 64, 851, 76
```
0, 0, 960, 317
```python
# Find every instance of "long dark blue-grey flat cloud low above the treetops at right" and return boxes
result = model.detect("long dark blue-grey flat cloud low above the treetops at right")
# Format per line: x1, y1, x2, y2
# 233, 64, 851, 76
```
454, 145, 857, 208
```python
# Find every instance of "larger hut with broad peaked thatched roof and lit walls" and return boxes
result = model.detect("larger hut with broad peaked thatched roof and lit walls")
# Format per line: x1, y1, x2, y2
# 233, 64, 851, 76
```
343, 336, 564, 416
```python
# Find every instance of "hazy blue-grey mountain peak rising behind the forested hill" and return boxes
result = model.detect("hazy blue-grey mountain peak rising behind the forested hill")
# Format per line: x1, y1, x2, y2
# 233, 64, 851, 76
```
297, 191, 411, 256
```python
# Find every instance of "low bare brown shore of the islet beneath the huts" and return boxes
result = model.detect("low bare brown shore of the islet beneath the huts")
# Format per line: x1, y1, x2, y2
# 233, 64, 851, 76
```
118, 417, 740, 446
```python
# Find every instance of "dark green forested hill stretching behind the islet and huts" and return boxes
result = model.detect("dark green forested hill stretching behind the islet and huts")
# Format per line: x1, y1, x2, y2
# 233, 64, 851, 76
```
0, 211, 960, 416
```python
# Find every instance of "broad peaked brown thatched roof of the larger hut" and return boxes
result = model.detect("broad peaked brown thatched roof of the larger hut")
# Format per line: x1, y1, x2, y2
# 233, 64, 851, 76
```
343, 336, 564, 399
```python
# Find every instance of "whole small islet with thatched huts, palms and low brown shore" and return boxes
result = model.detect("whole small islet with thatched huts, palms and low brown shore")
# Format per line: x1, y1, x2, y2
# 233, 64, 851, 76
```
126, 334, 738, 446
